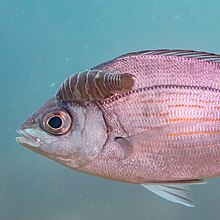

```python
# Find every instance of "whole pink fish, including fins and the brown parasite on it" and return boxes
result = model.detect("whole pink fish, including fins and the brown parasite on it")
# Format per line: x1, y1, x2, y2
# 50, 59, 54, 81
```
16, 49, 220, 207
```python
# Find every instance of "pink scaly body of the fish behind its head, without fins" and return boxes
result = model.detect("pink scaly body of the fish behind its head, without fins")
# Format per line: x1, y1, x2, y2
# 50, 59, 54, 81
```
82, 50, 220, 183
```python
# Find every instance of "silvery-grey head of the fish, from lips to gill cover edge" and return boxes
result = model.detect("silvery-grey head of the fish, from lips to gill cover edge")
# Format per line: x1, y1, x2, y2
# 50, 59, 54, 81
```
16, 98, 107, 169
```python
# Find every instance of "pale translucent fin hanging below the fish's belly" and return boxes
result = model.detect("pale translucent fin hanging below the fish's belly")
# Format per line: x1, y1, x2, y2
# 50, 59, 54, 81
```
141, 184, 194, 207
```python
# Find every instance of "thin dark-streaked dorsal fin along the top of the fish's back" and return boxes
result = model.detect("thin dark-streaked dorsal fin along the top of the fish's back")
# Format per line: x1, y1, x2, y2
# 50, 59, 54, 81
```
115, 49, 220, 63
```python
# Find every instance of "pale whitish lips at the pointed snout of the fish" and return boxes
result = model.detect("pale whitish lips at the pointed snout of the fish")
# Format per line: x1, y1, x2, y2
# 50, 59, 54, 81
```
15, 129, 41, 148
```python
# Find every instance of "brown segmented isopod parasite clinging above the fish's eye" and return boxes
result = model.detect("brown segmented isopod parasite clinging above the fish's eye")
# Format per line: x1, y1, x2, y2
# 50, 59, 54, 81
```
56, 70, 134, 102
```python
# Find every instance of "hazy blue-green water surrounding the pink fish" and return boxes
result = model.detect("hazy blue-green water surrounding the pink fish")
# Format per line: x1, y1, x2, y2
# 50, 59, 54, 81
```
0, 0, 220, 220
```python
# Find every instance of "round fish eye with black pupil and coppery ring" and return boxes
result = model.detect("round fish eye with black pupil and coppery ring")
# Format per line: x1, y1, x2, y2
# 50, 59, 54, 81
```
43, 111, 72, 135
